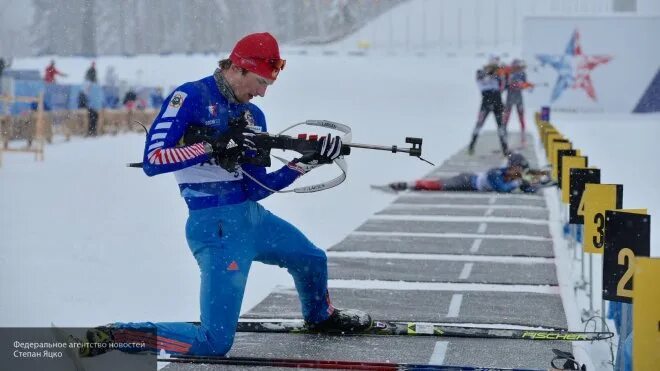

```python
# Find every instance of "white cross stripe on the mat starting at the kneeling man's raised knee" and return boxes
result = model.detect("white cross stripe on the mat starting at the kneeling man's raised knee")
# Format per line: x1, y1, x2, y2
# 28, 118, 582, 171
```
326, 251, 555, 264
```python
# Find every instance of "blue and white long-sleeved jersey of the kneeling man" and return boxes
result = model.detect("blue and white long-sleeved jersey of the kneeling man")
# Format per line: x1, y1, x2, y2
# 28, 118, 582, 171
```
143, 76, 301, 209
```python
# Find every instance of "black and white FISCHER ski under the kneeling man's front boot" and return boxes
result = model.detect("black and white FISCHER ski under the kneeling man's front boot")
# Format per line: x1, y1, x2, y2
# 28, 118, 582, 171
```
232, 320, 614, 341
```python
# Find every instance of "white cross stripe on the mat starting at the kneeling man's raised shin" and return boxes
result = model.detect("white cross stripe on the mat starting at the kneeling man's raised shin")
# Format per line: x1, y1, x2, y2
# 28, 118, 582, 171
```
328, 279, 559, 295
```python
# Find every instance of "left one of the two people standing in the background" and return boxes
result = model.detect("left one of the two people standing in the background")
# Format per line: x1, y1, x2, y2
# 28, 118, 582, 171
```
468, 59, 509, 155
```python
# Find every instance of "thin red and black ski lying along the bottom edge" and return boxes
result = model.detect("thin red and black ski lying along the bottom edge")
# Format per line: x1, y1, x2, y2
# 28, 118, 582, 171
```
158, 355, 547, 371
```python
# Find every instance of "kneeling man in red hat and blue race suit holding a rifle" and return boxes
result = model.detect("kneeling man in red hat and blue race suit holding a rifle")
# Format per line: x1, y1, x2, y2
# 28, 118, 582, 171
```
74, 33, 371, 356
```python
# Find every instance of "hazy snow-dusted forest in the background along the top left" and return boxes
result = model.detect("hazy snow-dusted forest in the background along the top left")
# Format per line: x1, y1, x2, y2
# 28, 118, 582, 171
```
32, 0, 403, 56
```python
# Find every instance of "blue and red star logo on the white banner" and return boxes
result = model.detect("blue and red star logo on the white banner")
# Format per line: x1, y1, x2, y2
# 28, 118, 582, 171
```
536, 29, 612, 102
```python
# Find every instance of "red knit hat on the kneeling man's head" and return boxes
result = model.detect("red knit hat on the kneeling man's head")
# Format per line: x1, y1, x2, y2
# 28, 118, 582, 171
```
229, 32, 286, 80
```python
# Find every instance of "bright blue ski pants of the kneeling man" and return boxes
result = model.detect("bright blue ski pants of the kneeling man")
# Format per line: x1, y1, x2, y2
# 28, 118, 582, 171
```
113, 201, 332, 355
